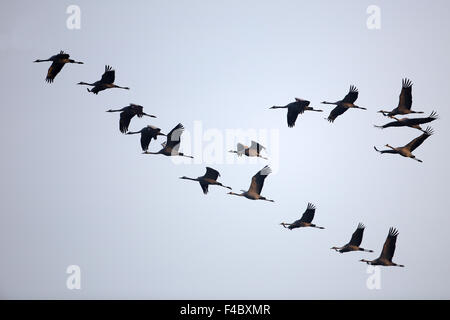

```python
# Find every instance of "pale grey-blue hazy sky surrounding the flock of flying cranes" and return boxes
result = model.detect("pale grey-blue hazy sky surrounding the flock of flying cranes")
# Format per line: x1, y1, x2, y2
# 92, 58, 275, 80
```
0, 0, 450, 299
